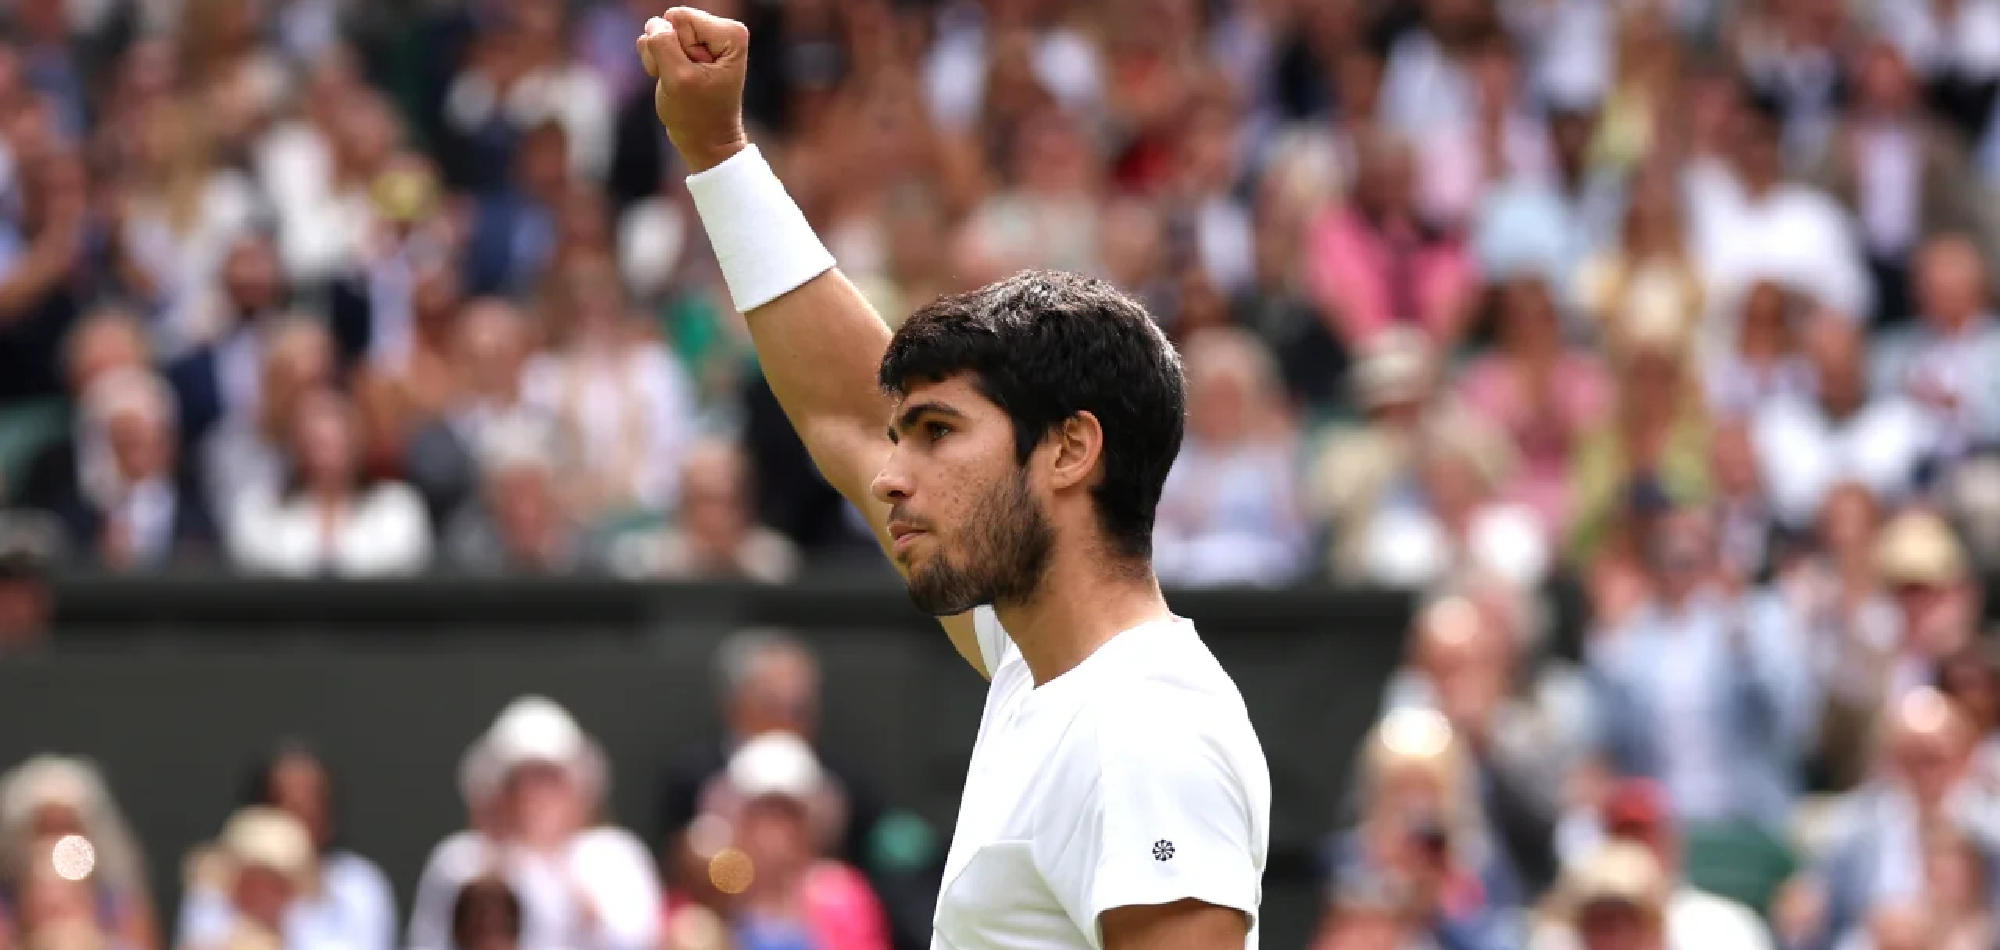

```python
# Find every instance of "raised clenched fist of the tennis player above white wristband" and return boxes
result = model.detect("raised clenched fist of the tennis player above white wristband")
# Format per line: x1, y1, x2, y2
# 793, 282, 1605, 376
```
638, 6, 750, 172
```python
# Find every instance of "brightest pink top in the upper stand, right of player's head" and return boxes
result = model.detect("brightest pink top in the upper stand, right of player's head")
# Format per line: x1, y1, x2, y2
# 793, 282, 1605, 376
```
1308, 208, 1476, 346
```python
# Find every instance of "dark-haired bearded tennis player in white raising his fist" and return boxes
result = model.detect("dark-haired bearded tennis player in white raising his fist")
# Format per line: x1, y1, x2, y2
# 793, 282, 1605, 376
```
638, 8, 1270, 950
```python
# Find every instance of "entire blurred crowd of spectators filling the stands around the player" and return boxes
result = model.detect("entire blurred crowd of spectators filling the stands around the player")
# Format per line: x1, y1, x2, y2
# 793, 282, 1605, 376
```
0, 0, 2000, 950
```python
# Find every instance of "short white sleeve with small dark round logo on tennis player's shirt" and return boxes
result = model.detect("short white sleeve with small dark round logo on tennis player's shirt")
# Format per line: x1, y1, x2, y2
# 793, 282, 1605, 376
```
1036, 704, 1268, 946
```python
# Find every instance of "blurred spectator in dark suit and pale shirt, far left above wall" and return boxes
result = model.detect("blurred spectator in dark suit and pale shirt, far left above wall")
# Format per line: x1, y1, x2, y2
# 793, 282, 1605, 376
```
20, 370, 218, 570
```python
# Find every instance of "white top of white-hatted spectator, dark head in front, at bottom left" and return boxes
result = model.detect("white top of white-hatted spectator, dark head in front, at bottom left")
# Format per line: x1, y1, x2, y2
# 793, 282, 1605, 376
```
408, 828, 660, 950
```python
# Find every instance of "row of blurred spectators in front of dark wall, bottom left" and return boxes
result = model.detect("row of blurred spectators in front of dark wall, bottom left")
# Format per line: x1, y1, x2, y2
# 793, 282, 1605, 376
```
0, 630, 942, 950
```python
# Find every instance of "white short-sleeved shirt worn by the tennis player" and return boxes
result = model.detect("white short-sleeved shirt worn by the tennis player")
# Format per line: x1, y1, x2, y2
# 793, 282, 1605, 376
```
930, 608, 1270, 950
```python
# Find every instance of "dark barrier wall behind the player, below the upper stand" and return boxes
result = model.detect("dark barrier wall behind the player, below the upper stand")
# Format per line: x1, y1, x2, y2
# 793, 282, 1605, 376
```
0, 580, 1408, 948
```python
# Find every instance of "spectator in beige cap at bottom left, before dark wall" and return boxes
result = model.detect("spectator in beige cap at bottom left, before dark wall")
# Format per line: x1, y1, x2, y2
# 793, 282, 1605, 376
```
180, 806, 318, 950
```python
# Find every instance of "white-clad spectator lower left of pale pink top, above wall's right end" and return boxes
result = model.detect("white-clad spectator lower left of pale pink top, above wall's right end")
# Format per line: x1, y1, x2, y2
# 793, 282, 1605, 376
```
1364, 412, 1550, 588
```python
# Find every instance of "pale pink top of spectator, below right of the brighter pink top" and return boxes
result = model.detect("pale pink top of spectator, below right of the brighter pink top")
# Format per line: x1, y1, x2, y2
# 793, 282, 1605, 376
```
1458, 350, 1612, 536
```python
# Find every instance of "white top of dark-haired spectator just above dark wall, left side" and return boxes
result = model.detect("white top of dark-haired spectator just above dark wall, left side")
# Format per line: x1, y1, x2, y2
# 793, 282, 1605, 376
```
228, 482, 430, 578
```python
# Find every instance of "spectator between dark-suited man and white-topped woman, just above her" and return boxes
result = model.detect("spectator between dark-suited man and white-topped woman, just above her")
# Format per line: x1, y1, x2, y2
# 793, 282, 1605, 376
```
202, 314, 334, 530
